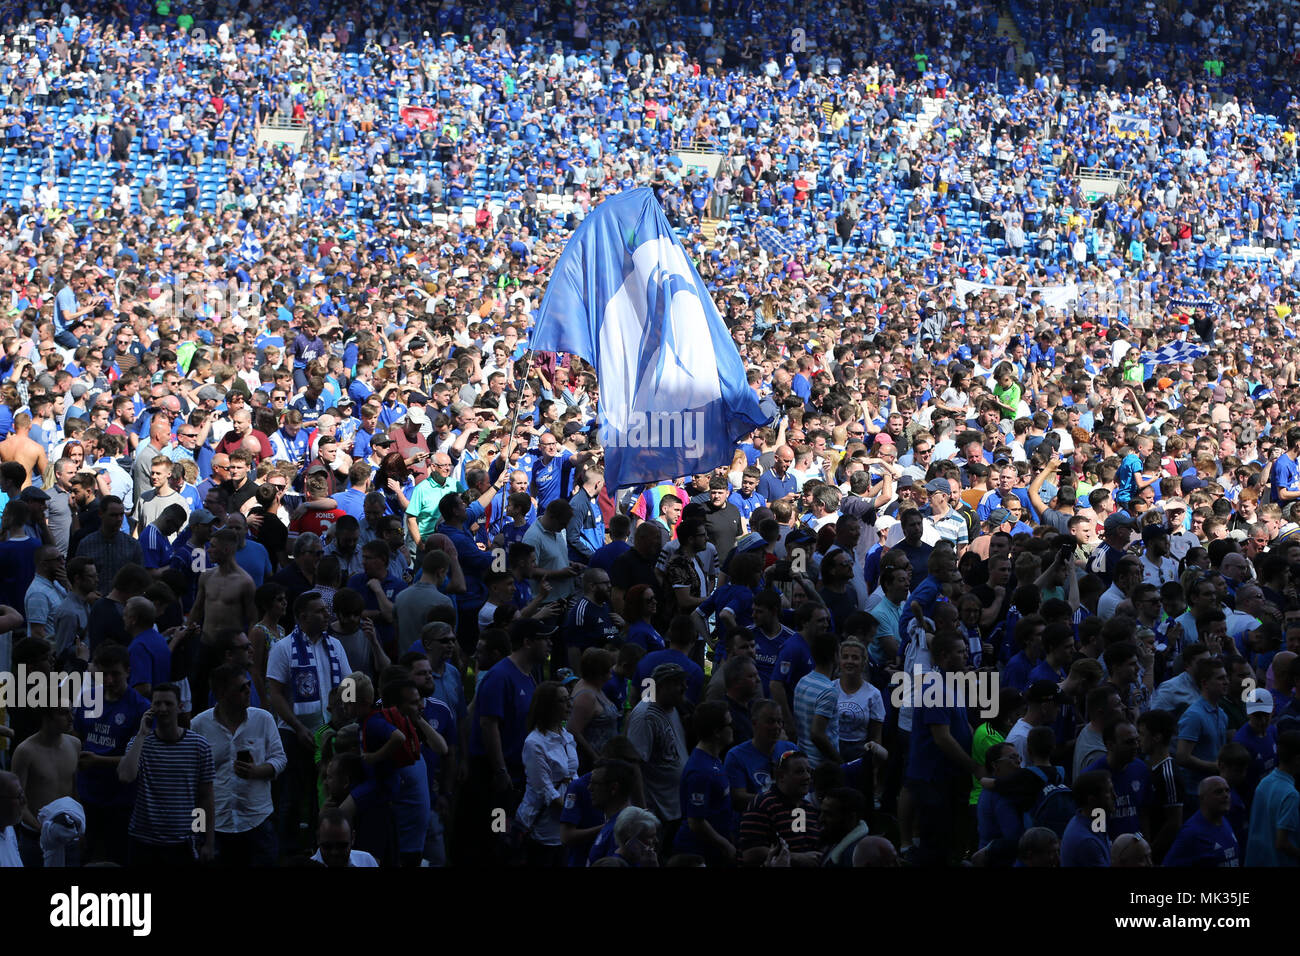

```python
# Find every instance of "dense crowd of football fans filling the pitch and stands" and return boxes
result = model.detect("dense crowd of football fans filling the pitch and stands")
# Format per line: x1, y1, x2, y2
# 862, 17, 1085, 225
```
0, 0, 1300, 868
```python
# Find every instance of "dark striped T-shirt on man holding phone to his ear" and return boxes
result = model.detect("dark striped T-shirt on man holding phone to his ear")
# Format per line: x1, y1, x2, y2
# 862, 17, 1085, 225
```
127, 730, 215, 845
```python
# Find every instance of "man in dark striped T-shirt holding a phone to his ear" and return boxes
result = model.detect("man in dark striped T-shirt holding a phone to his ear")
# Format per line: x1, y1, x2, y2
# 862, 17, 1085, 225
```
117, 684, 216, 868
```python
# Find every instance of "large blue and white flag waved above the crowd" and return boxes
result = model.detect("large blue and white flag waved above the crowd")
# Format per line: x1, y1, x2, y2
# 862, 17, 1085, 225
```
530, 189, 767, 489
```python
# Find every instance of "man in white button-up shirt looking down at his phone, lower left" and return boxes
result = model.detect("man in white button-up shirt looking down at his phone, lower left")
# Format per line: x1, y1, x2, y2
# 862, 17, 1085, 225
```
190, 661, 289, 866
